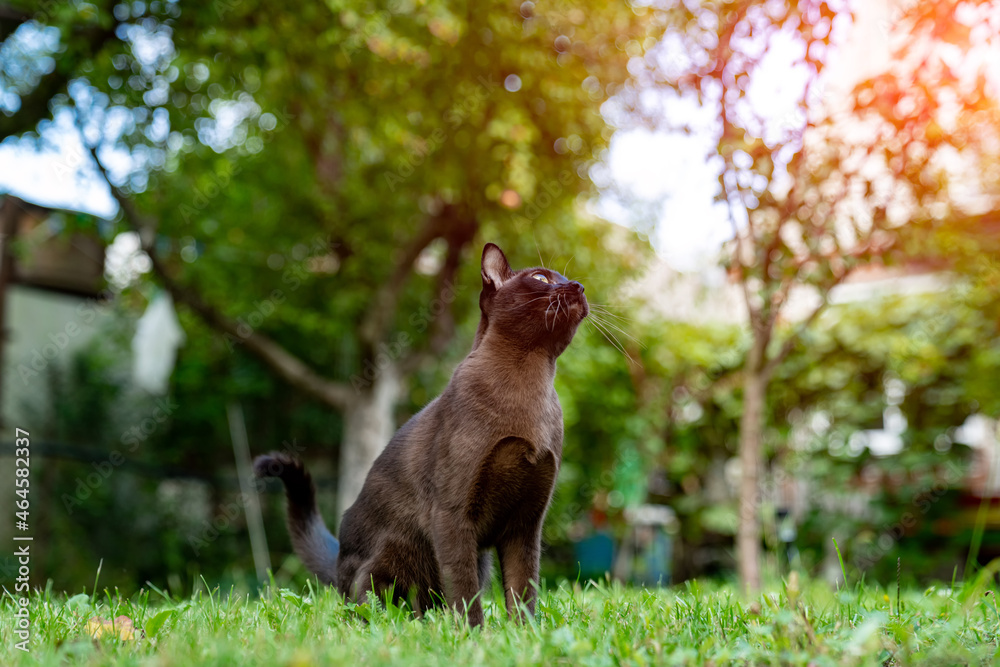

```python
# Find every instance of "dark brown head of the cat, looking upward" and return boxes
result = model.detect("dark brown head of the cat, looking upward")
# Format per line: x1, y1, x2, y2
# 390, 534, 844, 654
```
474, 243, 590, 356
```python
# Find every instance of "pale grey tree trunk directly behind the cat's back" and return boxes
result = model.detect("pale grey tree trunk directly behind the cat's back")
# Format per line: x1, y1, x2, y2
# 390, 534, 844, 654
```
337, 362, 403, 524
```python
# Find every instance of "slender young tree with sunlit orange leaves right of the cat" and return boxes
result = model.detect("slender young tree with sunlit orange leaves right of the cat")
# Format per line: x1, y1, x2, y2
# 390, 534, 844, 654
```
624, 1, 1000, 592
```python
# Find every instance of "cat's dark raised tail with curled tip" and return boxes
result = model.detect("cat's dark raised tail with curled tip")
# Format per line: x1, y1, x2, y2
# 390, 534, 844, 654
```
253, 452, 340, 585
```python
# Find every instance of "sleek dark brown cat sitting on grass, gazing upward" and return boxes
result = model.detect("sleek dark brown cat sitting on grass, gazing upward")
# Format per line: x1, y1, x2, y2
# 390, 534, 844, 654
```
255, 243, 590, 625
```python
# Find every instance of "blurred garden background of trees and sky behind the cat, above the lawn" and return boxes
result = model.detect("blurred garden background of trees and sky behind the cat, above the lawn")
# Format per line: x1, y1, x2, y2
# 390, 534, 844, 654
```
0, 0, 1000, 594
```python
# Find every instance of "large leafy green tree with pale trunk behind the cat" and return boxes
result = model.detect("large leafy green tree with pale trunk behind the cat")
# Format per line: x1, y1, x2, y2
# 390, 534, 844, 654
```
4, 0, 646, 511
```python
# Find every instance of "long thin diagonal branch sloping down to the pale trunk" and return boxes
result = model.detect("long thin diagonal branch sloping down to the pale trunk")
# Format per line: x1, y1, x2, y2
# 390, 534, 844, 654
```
90, 147, 354, 410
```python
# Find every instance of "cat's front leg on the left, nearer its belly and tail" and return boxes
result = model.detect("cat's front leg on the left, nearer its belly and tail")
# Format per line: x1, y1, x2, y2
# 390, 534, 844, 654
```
434, 511, 483, 626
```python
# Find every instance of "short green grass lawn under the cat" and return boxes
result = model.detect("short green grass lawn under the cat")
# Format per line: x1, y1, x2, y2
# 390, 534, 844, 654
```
0, 576, 1000, 667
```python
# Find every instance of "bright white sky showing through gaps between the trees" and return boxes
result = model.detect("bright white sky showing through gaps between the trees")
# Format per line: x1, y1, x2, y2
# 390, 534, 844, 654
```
0, 1, 888, 271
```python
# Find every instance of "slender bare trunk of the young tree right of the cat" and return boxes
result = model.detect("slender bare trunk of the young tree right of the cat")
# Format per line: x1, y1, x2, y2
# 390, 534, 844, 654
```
736, 360, 767, 595
